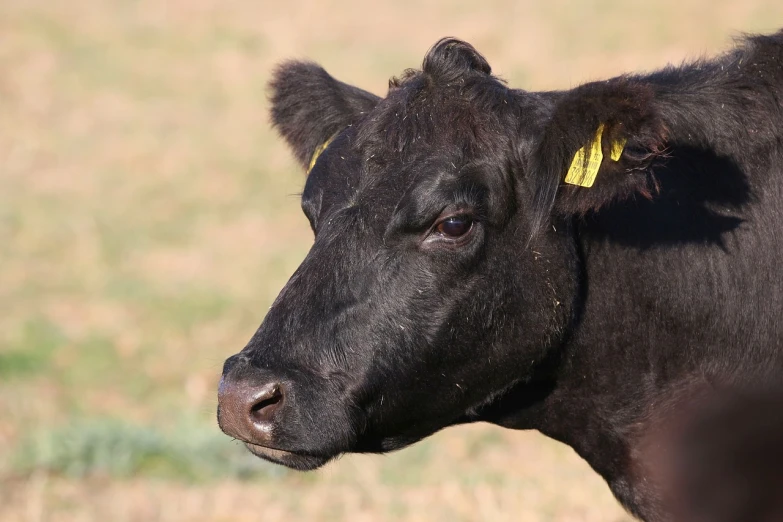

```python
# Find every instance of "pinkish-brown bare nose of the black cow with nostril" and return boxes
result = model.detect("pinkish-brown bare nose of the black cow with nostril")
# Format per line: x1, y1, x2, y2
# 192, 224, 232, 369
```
218, 376, 285, 445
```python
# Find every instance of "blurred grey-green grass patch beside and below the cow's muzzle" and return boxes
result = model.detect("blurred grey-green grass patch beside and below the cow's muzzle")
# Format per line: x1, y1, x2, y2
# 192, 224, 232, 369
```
11, 417, 286, 482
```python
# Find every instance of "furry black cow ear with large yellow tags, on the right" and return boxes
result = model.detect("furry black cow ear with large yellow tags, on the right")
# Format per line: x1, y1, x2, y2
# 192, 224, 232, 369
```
528, 77, 665, 232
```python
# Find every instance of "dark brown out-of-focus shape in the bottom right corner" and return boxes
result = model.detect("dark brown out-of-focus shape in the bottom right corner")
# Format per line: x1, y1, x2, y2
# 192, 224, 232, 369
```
670, 390, 783, 522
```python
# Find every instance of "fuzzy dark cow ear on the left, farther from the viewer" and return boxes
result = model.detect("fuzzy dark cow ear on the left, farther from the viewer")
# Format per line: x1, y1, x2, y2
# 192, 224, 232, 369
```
269, 61, 380, 168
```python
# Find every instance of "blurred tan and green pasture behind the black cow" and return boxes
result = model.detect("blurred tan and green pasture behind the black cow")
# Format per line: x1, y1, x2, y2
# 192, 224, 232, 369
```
0, 0, 783, 522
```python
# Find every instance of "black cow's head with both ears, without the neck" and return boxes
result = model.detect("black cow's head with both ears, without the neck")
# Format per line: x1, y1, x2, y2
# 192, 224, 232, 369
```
218, 39, 661, 469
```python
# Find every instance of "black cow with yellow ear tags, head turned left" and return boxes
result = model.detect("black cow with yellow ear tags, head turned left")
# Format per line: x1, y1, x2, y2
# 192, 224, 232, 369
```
218, 32, 783, 520
